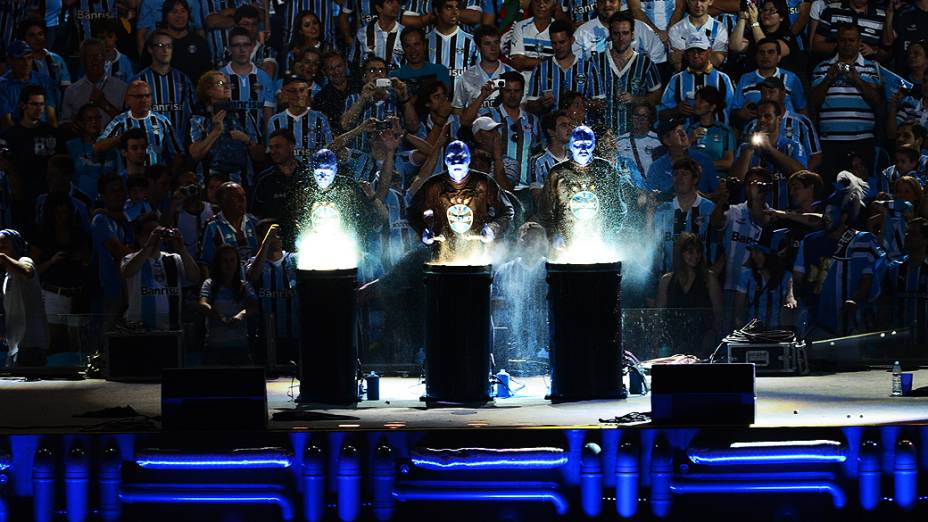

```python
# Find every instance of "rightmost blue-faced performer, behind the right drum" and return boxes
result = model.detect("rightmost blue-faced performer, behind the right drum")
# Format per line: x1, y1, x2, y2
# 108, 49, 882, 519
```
541, 125, 626, 248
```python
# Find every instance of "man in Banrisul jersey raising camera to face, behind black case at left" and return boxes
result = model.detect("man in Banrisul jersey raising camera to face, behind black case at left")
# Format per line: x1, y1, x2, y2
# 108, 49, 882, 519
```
120, 213, 200, 330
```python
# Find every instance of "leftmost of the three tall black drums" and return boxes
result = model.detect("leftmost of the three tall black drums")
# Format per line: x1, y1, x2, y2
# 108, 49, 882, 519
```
297, 268, 358, 404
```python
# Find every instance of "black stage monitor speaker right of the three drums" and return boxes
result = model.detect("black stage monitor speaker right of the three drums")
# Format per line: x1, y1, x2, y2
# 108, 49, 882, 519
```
651, 364, 756, 426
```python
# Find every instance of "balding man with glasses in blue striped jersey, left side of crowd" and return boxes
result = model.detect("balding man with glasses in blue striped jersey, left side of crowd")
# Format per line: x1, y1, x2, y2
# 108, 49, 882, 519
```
93, 80, 183, 165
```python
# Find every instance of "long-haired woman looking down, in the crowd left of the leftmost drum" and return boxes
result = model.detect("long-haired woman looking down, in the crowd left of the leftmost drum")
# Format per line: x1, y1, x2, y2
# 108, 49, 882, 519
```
198, 245, 259, 365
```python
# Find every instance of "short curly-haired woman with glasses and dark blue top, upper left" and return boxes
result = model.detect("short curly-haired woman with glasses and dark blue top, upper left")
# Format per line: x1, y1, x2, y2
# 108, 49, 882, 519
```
189, 71, 264, 183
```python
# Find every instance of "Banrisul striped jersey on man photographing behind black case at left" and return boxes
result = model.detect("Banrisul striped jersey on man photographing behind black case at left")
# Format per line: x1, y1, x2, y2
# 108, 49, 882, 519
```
122, 251, 186, 330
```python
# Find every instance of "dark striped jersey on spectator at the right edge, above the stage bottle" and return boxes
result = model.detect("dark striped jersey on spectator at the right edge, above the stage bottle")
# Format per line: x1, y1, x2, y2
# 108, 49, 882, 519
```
886, 256, 928, 332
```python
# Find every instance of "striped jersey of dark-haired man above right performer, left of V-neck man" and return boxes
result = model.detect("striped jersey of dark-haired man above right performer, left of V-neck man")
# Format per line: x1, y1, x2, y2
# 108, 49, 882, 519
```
525, 55, 604, 107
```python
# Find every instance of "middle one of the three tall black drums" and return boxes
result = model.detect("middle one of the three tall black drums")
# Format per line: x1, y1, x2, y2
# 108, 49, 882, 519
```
423, 263, 492, 403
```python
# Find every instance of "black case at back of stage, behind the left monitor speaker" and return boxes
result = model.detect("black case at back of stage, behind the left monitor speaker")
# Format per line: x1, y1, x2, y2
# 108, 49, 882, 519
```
103, 330, 184, 381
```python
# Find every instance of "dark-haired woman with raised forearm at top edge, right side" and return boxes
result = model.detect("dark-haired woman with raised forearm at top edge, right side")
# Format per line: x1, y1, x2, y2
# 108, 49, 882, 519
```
729, 0, 806, 76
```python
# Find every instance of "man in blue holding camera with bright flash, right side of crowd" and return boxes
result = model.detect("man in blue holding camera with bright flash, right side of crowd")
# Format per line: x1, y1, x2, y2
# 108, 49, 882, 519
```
731, 101, 809, 210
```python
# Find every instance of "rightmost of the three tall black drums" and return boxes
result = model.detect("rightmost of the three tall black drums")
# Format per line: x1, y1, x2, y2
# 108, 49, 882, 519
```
546, 262, 627, 402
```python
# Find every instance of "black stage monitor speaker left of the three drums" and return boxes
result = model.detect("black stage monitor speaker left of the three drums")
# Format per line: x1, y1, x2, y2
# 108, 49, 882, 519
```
161, 367, 267, 430
